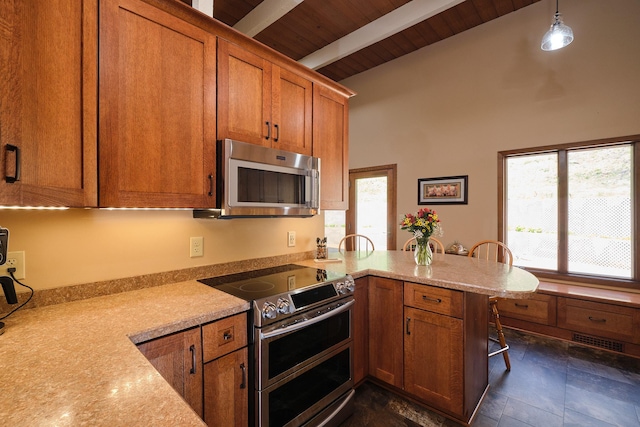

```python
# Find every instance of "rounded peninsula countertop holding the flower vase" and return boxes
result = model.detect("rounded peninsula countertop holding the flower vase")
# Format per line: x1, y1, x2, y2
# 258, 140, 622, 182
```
296, 251, 539, 298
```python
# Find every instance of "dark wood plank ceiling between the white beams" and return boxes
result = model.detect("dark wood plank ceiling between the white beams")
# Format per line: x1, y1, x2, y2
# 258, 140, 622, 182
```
182, 0, 540, 81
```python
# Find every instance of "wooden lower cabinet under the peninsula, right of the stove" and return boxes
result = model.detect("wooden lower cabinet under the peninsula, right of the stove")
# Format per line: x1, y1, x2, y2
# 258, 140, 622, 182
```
364, 276, 489, 423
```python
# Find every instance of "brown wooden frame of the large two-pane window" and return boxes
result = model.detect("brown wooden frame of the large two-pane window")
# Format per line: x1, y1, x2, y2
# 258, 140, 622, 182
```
498, 135, 640, 290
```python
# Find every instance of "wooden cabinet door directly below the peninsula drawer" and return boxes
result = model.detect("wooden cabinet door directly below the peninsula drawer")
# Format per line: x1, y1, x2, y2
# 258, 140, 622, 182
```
404, 307, 464, 415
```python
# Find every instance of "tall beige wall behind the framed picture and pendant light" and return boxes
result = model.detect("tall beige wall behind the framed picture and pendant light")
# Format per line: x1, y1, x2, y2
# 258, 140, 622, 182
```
342, 0, 640, 251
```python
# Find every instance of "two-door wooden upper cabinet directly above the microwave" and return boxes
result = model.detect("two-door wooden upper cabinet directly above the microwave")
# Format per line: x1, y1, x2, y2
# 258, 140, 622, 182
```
218, 39, 313, 155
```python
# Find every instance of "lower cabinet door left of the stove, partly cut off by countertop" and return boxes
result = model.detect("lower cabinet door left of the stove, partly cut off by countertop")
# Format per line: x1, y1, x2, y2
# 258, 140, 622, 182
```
138, 328, 202, 417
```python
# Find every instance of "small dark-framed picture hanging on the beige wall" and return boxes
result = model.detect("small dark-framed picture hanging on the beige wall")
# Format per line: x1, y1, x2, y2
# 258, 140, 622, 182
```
418, 175, 469, 205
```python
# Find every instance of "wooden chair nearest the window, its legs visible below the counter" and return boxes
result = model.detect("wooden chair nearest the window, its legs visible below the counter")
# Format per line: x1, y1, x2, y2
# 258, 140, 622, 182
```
468, 240, 513, 371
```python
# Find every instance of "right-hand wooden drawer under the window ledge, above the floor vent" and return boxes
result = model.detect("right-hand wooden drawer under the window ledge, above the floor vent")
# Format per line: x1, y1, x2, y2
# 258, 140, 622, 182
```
558, 298, 640, 343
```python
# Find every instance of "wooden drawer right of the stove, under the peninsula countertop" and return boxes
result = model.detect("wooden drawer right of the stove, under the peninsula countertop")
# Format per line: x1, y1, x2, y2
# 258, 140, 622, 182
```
404, 282, 463, 318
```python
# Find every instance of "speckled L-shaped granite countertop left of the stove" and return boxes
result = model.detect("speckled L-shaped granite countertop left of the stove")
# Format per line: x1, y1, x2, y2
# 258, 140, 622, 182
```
0, 281, 249, 427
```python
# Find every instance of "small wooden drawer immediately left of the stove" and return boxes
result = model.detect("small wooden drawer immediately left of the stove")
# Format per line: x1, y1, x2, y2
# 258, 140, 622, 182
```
202, 313, 247, 363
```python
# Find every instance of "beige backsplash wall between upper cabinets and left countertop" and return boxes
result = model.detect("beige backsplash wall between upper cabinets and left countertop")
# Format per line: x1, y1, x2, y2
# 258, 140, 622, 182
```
0, 209, 323, 297
